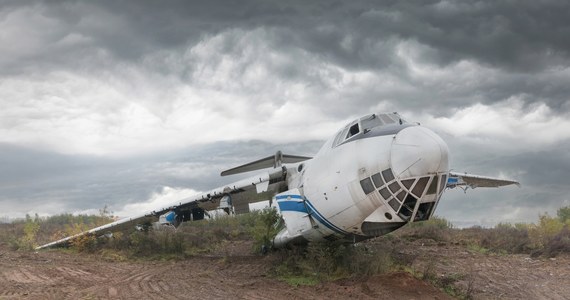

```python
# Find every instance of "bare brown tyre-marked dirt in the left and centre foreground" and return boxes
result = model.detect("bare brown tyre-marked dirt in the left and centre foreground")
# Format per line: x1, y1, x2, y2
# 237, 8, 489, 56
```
0, 244, 448, 299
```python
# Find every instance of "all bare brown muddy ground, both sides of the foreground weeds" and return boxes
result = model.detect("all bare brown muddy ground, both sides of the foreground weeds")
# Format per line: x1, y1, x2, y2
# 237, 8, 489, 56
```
0, 240, 570, 299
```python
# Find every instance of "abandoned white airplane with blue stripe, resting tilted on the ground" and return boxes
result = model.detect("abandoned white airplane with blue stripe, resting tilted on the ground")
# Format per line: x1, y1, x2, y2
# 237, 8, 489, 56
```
37, 112, 519, 249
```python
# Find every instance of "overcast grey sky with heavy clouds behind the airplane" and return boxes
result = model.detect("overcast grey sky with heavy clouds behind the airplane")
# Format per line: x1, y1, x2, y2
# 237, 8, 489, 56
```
0, 1, 570, 224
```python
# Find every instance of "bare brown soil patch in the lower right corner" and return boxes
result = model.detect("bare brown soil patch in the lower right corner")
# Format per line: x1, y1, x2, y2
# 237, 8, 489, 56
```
403, 240, 570, 299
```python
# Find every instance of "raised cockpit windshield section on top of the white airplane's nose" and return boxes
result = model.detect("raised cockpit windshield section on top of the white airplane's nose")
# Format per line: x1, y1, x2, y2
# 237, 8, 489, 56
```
332, 113, 407, 148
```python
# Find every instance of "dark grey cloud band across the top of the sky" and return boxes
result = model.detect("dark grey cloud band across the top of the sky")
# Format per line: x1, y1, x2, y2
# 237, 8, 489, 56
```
0, 0, 570, 113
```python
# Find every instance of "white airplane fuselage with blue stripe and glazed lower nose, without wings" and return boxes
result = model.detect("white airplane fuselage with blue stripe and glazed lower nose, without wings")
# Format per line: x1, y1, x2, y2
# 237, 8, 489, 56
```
274, 115, 449, 246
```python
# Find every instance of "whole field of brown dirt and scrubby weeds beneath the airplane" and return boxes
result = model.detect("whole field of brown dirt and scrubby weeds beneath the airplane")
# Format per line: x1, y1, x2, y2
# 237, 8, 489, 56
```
0, 211, 570, 299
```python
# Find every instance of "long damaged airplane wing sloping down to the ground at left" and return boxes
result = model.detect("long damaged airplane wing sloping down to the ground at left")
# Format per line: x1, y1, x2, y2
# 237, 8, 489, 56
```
36, 167, 287, 250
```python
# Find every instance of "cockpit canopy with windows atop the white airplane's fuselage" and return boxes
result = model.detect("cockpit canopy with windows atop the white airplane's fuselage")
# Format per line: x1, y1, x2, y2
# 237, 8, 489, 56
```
332, 112, 408, 148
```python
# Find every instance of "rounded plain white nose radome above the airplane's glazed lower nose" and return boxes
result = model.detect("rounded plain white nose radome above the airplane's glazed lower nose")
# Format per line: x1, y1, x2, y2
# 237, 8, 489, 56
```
390, 126, 449, 177
